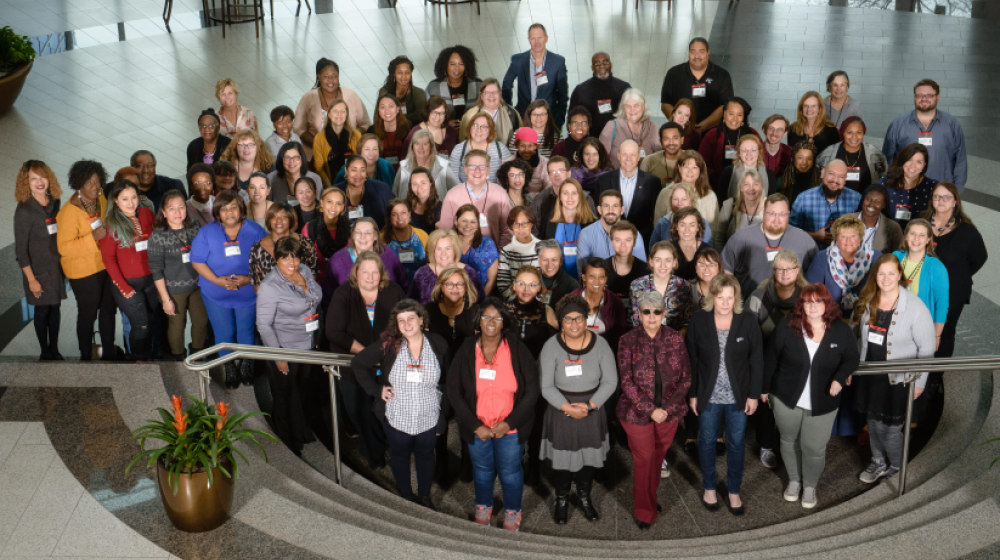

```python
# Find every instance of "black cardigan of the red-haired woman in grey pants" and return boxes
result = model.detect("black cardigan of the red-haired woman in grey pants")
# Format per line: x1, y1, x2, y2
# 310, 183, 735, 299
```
761, 317, 861, 416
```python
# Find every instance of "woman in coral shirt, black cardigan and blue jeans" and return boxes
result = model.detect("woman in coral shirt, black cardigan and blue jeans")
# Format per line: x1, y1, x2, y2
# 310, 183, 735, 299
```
448, 297, 540, 531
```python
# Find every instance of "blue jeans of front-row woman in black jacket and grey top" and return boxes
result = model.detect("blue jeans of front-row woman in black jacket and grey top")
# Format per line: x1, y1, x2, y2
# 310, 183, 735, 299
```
698, 403, 747, 494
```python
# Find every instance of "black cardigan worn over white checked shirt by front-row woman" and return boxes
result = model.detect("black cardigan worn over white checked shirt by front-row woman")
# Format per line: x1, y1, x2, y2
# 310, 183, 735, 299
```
351, 332, 451, 434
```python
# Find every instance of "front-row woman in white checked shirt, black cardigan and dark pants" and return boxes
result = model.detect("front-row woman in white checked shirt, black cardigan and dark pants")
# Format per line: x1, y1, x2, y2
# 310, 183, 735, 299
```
351, 299, 450, 509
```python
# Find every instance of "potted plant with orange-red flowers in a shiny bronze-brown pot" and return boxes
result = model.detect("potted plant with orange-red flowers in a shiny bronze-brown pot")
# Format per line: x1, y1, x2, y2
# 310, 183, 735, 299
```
125, 395, 278, 533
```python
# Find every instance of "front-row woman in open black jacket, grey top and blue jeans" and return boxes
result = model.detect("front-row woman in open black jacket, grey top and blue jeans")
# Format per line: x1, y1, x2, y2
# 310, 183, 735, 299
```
687, 274, 764, 515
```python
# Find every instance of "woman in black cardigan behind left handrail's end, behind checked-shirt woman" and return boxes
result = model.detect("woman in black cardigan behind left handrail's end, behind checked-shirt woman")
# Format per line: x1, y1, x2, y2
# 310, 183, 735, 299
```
326, 251, 406, 468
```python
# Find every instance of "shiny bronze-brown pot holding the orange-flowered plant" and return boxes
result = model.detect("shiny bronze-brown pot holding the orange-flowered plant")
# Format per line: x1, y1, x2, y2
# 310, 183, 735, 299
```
156, 461, 233, 533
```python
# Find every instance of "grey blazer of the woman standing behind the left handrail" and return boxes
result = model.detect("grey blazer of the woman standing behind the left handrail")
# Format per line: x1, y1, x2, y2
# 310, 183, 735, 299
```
257, 264, 323, 350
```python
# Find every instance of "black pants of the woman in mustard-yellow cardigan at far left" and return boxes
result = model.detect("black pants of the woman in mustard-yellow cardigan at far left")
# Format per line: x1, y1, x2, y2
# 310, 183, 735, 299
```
69, 270, 118, 361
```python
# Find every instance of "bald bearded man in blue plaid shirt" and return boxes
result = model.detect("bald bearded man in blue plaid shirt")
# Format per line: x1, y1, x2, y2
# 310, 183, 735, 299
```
789, 159, 861, 249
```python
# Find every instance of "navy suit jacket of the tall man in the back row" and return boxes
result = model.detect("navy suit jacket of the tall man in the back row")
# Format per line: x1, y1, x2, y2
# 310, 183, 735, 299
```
502, 51, 569, 129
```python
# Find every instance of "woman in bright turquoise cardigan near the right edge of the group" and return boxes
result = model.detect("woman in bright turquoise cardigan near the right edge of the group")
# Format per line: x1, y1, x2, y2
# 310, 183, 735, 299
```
893, 218, 948, 349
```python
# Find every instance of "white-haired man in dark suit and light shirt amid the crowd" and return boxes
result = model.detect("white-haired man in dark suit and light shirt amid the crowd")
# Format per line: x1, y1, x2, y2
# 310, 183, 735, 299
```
597, 140, 661, 239
